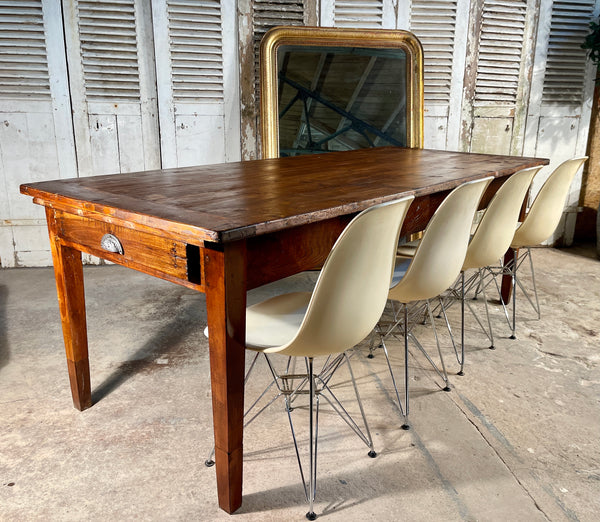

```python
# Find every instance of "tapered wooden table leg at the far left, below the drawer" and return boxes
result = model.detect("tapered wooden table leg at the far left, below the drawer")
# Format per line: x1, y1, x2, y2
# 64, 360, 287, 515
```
46, 208, 92, 411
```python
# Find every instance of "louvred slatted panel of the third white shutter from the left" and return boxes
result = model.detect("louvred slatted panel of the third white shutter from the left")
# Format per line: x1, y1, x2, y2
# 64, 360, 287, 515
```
167, 0, 223, 102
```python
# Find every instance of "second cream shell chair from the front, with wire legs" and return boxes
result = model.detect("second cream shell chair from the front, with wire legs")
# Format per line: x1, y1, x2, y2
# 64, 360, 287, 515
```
379, 177, 492, 429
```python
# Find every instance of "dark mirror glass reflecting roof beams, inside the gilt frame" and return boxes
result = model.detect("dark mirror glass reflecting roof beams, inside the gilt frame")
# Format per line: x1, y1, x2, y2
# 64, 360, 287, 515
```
277, 45, 406, 156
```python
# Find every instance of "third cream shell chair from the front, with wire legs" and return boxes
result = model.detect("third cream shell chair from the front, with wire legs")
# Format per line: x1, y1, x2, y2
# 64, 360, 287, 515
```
453, 167, 542, 375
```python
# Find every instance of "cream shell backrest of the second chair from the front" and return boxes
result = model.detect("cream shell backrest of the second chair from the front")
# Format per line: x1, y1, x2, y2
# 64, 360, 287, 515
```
389, 177, 492, 303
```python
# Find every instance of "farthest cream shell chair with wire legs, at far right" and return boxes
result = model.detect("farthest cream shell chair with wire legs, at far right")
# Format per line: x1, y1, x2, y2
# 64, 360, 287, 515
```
507, 156, 588, 339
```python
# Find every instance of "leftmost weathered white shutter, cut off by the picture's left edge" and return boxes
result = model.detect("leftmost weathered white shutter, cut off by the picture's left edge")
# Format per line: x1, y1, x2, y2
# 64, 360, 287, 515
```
0, 0, 77, 267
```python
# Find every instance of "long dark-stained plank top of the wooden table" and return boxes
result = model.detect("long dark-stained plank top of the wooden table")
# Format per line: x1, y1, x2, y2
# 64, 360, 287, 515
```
21, 147, 548, 242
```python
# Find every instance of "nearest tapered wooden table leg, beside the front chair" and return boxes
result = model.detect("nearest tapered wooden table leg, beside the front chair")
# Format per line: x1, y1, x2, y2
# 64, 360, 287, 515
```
204, 242, 246, 513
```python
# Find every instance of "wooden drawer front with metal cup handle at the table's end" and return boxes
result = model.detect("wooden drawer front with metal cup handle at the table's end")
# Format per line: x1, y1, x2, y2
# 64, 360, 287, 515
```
56, 212, 203, 290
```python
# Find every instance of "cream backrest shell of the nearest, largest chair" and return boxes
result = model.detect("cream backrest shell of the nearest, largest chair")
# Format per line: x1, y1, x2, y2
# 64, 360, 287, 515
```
277, 196, 414, 357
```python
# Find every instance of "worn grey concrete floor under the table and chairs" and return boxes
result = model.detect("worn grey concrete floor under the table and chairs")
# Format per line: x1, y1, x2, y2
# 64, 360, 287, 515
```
0, 247, 600, 522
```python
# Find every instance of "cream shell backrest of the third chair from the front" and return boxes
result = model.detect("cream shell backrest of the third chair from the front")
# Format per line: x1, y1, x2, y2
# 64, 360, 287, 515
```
462, 166, 542, 270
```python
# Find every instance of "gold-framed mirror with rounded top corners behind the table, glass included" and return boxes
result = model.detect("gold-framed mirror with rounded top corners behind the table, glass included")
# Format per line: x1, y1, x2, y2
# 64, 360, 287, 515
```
260, 27, 423, 158
